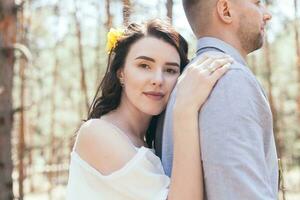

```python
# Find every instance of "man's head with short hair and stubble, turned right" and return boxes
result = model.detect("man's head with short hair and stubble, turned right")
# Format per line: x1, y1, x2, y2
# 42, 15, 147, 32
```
183, 0, 271, 55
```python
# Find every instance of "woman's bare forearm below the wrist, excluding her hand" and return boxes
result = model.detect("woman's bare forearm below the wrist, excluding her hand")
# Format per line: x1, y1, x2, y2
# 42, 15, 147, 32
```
169, 104, 203, 200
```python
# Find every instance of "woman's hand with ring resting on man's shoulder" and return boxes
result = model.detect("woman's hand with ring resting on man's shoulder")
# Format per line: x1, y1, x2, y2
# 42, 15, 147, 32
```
175, 53, 233, 112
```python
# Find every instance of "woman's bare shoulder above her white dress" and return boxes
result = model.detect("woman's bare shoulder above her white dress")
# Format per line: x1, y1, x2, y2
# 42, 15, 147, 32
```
75, 119, 136, 175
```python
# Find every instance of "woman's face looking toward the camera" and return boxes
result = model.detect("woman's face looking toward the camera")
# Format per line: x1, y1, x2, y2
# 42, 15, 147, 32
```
118, 37, 180, 115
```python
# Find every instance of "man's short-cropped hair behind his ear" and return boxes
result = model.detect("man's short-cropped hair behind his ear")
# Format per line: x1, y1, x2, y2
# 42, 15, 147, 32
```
182, 0, 217, 36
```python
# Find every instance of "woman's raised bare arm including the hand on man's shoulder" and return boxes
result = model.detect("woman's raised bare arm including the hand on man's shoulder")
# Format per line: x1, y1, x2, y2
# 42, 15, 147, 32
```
168, 55, 232, 200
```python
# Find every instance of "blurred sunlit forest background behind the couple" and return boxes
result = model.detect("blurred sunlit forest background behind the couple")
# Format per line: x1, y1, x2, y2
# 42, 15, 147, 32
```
0, 0, 300, 200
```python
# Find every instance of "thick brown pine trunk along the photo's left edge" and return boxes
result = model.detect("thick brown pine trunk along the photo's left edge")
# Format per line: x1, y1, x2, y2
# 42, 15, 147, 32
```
0, 0, 17, 200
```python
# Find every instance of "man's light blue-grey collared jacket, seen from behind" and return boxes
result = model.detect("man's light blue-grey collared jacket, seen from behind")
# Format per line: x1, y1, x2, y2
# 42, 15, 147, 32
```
156, 37, 278, 200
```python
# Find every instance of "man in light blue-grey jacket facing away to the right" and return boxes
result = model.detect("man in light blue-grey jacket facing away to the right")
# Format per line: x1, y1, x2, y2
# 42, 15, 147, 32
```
158, 0, 278, 200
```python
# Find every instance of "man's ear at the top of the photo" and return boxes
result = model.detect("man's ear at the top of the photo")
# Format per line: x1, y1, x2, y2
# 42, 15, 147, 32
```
217, 0, 233, 24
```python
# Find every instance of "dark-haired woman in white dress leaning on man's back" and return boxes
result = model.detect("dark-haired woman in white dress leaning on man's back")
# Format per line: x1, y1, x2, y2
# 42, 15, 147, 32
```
67, 20, 232, 200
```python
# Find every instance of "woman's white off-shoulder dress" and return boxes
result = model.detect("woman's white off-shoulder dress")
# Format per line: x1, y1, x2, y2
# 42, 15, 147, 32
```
67, 129, 170, 200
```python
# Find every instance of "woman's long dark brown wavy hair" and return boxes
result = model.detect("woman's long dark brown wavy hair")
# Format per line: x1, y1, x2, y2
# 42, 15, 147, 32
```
87, 19, 188, 147
